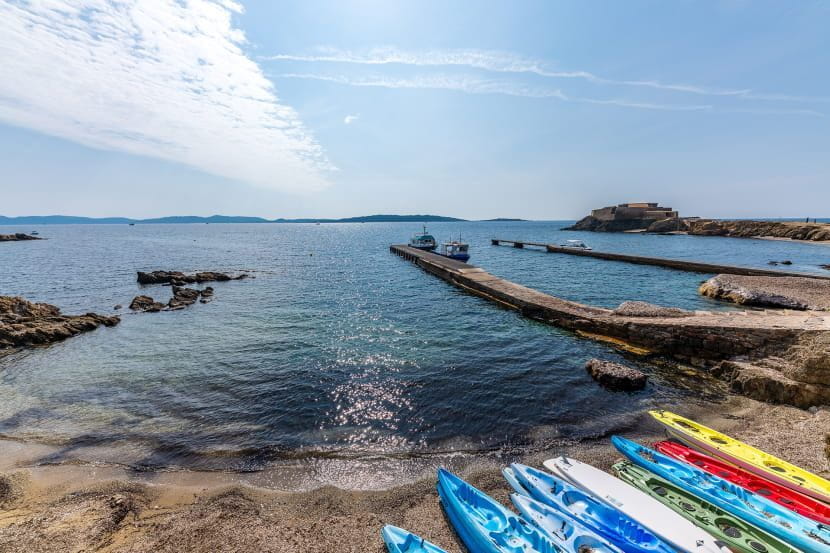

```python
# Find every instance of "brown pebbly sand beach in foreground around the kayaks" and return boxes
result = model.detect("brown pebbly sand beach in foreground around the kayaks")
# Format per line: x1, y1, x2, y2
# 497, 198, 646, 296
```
0, 397, 830, 553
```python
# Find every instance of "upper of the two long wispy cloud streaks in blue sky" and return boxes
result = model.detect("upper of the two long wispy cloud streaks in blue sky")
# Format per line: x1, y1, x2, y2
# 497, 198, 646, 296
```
262, 47, 751, 97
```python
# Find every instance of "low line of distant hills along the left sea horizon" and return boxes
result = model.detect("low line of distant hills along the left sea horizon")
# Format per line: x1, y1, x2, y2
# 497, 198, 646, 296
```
0, 215, 465, 225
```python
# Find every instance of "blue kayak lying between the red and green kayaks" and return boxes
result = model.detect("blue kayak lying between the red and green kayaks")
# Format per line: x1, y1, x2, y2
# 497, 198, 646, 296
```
611, 436, 830, 553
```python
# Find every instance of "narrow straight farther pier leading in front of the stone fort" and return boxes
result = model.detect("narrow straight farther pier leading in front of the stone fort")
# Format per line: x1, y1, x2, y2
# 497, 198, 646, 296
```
491, 238, 830, 280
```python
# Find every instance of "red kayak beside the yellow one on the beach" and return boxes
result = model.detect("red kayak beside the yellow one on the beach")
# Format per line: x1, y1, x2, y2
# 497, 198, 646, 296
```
654, 441, 830, 525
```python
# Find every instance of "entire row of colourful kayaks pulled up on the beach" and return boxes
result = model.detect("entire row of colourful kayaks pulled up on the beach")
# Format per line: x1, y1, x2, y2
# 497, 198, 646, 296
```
381, 411, 830, 553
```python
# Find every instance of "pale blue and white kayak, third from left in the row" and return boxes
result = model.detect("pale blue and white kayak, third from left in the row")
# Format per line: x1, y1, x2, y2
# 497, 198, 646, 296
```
510, 493, 621, 553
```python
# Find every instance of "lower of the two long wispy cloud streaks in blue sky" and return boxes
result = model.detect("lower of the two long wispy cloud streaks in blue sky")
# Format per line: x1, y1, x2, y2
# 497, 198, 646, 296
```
275, 73, 712, 111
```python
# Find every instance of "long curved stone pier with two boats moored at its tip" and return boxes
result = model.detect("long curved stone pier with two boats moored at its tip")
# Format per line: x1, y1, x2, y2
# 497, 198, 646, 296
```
389, 245, 830, 388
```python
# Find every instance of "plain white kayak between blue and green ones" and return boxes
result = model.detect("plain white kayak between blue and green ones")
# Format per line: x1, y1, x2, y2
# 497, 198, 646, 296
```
543, 457, 729, 553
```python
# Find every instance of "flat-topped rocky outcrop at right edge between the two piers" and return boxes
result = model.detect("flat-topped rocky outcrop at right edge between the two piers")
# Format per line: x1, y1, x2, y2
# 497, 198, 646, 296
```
698, 275, 830, 310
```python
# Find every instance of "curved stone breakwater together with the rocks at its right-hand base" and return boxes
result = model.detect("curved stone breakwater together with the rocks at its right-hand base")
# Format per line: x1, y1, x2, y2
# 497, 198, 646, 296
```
391, 246, 830, 408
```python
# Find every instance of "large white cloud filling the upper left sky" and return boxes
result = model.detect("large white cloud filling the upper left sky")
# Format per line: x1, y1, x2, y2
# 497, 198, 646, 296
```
0, 0, 332, 192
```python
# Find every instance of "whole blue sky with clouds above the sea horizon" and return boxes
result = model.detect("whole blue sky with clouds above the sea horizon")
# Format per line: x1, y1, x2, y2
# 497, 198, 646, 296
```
0, 0, 830, 220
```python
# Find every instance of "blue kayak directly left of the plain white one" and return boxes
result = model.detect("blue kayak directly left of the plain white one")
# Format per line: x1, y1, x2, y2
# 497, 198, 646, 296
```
508, 463, 675, 553
